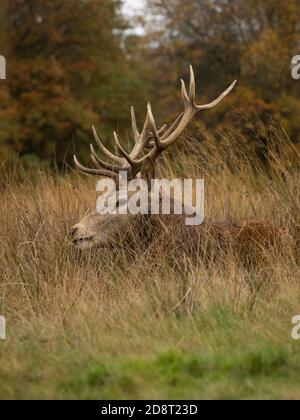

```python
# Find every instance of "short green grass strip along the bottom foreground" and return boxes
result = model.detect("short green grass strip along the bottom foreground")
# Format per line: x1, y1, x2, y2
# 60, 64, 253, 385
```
0, 310, 300, 399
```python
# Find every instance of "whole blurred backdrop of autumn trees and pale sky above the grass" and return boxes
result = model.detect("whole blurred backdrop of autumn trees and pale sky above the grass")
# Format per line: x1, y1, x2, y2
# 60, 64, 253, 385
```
0, 0, 300, 169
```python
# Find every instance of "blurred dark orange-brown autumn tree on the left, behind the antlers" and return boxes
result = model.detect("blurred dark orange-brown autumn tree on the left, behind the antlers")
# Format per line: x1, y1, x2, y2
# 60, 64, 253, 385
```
0, 0, 150, 167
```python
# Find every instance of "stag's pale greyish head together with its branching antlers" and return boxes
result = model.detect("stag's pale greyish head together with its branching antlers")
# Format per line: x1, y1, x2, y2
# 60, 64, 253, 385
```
70, 66, 236, 249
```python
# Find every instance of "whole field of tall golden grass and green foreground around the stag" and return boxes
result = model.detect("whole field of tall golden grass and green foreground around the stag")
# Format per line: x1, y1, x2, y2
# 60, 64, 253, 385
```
0, 132, 300, 399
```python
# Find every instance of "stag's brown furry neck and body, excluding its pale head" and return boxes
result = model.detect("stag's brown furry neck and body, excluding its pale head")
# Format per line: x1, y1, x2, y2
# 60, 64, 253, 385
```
122, 215, 283, 263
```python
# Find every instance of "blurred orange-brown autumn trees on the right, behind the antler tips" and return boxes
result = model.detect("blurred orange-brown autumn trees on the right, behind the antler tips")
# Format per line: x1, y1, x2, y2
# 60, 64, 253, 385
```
148, 0, 300, 142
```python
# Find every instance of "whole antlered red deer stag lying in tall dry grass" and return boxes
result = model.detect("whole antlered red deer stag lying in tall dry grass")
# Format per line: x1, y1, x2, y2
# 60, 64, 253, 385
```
69, 66, 278, 257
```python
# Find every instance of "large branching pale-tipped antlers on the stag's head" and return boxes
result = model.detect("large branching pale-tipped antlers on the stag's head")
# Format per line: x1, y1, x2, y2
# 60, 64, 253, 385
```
74, 66, 237, 179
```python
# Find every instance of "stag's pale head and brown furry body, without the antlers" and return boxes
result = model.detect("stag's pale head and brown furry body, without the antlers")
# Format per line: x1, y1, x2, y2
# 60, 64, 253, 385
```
70, 190, 284, 263
